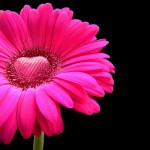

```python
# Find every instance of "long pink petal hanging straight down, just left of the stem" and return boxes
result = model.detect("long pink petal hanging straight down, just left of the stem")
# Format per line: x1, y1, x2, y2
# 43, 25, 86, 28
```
17, 88, 36, 139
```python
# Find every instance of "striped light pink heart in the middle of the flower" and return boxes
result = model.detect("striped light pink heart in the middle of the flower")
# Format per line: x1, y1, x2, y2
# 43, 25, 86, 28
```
14, 56, 50, 80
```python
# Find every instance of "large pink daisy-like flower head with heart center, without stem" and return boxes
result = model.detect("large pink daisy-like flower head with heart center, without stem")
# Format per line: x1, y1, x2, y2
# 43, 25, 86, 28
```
0, 3, 114, 144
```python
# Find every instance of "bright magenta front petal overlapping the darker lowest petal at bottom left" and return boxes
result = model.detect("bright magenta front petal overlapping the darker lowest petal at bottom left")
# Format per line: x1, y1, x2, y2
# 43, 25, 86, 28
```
0, 86, 21, 126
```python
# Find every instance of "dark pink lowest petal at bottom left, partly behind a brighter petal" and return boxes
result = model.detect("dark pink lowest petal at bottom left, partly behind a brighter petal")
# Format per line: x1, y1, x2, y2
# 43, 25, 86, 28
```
0, 109, 17, 144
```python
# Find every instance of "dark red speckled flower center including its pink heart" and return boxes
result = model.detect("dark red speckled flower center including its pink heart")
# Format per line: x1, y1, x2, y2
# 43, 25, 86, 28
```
4, 49, 60, 90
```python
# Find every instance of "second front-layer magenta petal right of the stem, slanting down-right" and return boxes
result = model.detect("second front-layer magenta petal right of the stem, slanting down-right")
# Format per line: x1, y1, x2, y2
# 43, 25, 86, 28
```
43, 83, 73, 108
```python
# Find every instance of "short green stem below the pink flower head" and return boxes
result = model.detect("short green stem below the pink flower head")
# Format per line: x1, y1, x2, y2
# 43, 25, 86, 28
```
33, 132, 44, 150
